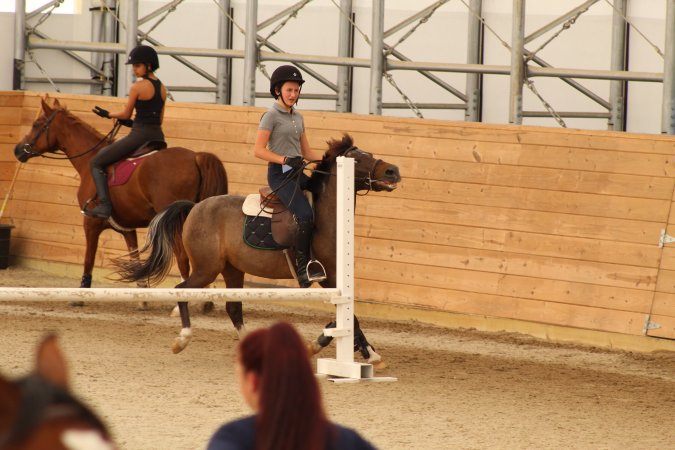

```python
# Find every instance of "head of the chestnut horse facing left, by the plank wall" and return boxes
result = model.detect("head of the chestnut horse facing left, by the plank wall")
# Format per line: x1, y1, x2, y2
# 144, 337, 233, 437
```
14, 99, 65, 162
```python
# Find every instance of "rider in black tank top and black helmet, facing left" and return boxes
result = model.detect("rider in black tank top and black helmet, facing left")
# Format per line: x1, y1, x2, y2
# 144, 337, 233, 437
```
82, 45, 166, 219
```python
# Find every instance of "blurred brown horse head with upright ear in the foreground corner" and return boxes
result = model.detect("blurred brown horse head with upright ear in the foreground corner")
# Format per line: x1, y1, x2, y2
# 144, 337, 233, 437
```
0, 335, 115, 450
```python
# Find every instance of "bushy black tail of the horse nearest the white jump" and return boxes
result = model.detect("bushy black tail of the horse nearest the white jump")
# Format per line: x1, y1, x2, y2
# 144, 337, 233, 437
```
113, 200, 195, 285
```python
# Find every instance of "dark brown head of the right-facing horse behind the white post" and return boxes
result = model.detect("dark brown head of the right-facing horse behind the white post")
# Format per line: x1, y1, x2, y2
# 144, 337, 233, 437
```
317, 134, 401, 192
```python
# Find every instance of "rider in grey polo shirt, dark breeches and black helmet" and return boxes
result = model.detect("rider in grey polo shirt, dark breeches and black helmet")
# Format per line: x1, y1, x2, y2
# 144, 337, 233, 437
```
254, 65, 326, 287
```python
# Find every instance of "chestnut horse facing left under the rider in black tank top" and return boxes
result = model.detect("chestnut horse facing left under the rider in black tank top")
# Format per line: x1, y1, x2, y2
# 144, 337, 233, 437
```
14, 96, 227, 288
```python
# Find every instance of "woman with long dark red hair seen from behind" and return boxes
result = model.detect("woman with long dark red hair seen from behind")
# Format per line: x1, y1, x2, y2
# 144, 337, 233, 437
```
208, 322, 374, 450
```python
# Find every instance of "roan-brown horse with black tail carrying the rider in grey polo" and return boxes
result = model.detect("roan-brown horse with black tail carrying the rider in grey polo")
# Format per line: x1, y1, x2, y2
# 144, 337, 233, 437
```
114, 135, 401, 364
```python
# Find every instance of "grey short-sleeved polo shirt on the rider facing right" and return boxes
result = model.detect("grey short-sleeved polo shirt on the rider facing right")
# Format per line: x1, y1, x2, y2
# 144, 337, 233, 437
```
258, 103, 305, 158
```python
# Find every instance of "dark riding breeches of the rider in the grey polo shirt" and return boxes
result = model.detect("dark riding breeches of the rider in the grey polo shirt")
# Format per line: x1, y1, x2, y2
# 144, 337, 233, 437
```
267, 163, 314, 222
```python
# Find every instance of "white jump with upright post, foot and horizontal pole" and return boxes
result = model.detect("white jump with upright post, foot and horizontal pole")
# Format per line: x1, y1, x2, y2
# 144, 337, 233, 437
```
0, 157, 373, 379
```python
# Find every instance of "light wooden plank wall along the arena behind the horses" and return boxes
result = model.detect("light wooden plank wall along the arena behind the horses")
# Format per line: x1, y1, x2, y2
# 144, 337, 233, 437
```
0, 92, 675, 339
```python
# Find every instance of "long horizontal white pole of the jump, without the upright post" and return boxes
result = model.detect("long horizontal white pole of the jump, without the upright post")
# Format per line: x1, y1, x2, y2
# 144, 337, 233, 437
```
0, 287, 340, 302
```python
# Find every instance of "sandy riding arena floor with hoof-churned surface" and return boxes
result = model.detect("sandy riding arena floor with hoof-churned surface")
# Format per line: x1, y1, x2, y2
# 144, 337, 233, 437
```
0, 267, 675, 450
